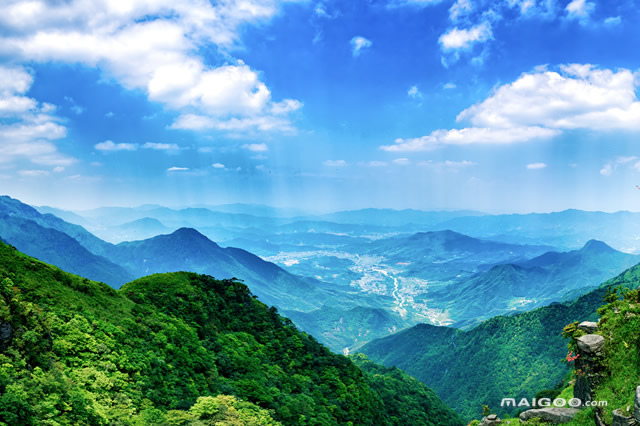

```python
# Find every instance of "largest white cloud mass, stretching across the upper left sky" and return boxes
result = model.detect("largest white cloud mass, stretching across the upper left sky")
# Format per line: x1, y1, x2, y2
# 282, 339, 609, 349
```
0, 0, 304, 130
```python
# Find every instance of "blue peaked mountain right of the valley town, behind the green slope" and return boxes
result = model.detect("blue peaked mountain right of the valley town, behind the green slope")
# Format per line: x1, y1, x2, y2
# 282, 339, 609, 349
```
418, 240, 640, 327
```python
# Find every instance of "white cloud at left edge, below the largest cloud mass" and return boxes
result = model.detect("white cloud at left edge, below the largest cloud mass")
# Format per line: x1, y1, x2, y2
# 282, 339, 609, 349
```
0, 65, 75, 166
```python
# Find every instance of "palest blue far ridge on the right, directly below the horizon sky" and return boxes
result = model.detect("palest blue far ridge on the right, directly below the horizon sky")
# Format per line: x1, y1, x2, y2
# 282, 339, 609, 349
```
432, 209, 640, 253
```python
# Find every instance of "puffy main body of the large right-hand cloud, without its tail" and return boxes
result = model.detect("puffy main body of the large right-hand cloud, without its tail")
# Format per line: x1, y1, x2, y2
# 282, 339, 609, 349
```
458, 64, 640, 130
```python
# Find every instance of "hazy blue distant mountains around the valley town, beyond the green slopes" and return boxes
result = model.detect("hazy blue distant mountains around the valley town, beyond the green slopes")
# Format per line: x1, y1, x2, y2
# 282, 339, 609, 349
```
6, 193, 637, 351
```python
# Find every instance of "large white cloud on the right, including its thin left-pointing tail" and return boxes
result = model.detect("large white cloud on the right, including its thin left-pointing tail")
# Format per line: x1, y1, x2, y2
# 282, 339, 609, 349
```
381, 64, 640, 152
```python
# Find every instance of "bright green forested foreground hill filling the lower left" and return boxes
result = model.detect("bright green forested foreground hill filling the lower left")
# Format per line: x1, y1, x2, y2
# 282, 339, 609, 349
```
0, 243, 462, 425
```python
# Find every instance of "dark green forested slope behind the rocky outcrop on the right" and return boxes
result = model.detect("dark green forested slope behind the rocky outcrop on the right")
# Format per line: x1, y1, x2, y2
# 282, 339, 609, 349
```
360, 265, 640, 420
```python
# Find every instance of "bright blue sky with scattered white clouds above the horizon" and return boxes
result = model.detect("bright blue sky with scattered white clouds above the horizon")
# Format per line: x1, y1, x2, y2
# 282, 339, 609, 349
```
0, 0, 640, 213
